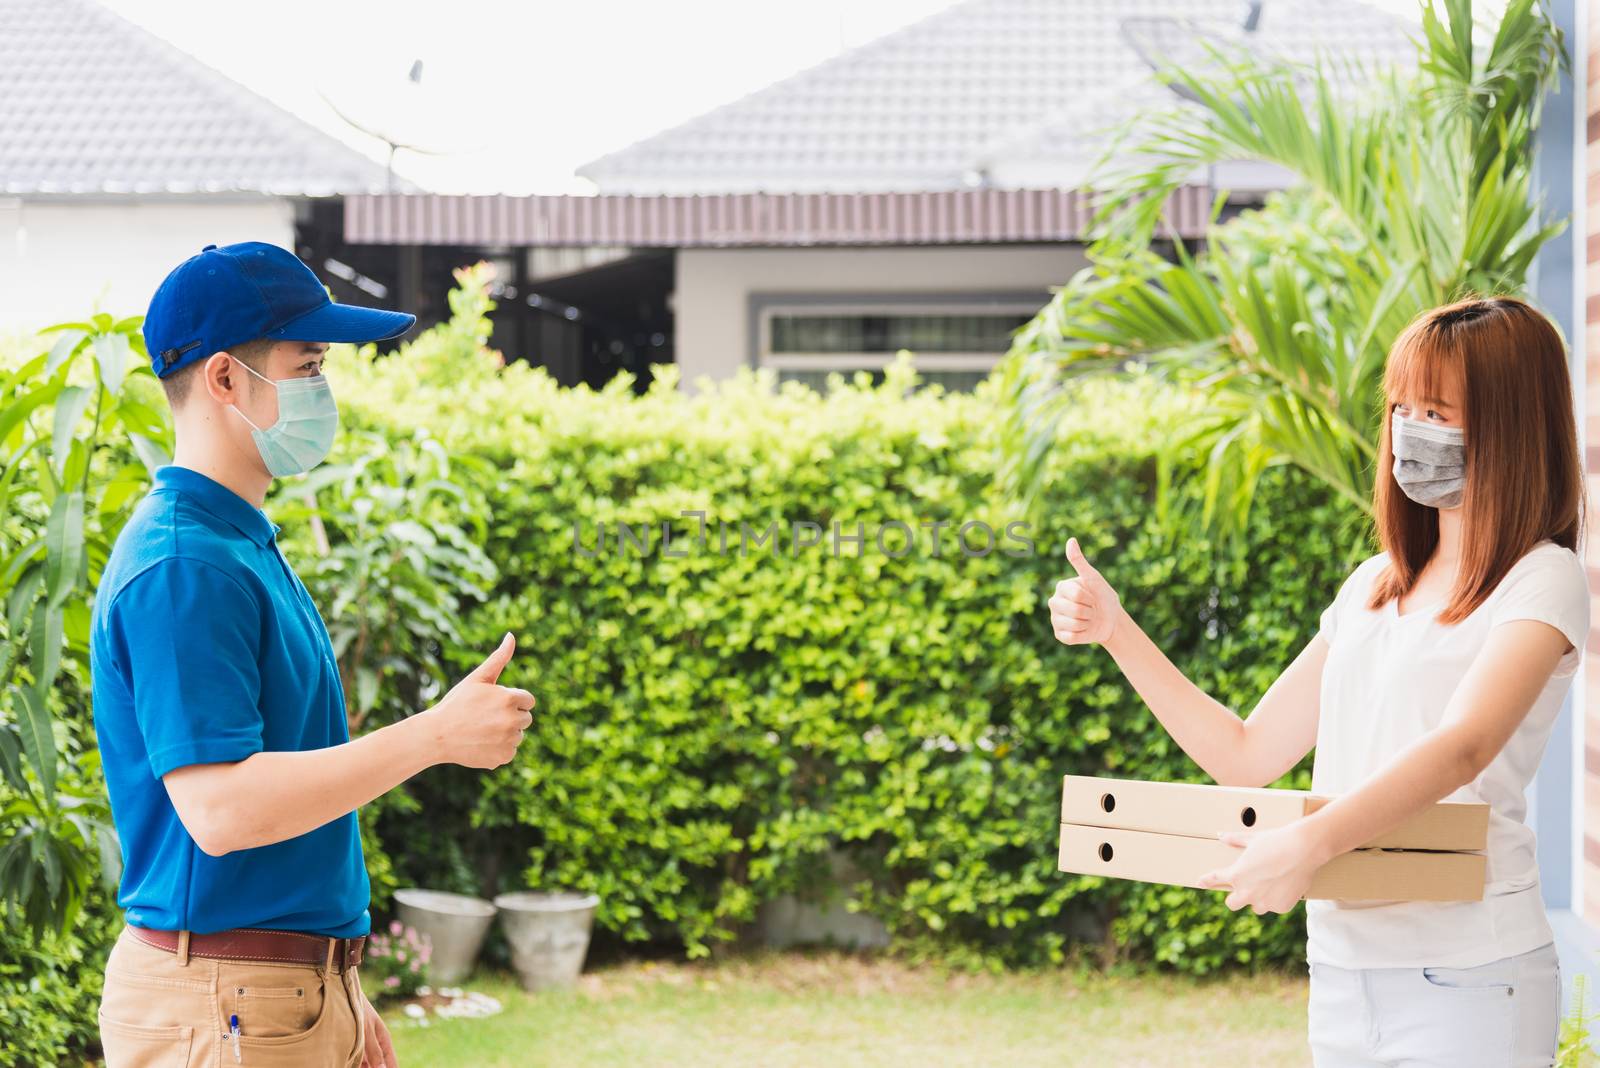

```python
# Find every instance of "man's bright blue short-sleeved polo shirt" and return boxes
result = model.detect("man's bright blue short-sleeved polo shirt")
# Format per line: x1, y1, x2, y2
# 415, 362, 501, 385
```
90, 467, 370, 937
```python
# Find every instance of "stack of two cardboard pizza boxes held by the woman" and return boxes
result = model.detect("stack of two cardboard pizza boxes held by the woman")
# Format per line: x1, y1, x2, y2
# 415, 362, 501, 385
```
1059, 775, 1490, 902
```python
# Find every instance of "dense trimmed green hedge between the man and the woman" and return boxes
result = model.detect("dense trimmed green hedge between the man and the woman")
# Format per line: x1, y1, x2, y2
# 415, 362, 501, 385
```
305, 295, 1360, 972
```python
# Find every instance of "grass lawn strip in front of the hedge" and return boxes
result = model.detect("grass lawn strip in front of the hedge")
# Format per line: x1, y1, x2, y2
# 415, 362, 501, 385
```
389, 954, 1310, 1068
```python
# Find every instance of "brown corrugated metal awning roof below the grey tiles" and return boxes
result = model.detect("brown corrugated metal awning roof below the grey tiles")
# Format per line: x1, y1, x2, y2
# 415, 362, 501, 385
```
344, 185, 1213, 248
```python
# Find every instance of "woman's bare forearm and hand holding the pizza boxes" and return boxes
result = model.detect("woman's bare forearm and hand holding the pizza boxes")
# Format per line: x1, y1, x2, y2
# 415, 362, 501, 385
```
1198, 619, 1571, 915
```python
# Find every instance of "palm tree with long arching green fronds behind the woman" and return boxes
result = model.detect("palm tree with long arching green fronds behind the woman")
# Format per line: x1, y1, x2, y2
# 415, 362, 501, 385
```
1000, 0, 1566, 534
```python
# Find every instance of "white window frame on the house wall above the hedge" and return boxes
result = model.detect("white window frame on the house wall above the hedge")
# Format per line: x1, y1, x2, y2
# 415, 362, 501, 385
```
755, 294, 1048, 371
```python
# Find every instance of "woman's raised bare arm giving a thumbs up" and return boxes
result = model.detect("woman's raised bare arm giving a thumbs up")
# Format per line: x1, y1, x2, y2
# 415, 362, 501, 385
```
1050, 537, 1328, 787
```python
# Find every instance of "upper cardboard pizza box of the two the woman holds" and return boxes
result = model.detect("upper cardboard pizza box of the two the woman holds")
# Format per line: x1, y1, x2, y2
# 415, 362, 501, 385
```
1061, 775, 1490, 849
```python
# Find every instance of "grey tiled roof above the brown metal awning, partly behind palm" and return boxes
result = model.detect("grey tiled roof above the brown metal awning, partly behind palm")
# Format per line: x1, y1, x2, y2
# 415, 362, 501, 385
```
578, 0, 1414, 193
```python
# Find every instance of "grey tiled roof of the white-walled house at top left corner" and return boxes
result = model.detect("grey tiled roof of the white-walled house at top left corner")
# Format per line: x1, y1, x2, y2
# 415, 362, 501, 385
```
0, 0, 398, 197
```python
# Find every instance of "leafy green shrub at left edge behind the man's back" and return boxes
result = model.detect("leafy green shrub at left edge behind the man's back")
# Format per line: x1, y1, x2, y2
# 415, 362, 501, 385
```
0, 313, 152, 934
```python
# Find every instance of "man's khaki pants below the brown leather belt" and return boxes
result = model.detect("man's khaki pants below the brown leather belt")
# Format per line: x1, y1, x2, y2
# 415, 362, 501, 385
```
99, 929, 363, 1068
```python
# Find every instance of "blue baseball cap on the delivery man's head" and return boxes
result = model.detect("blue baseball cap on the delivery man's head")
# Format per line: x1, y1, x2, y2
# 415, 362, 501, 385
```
144, 241, 416, 379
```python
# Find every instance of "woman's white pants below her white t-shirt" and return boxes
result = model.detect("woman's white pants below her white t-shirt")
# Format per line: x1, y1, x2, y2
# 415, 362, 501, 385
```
1307, 943, 1562, 1068
